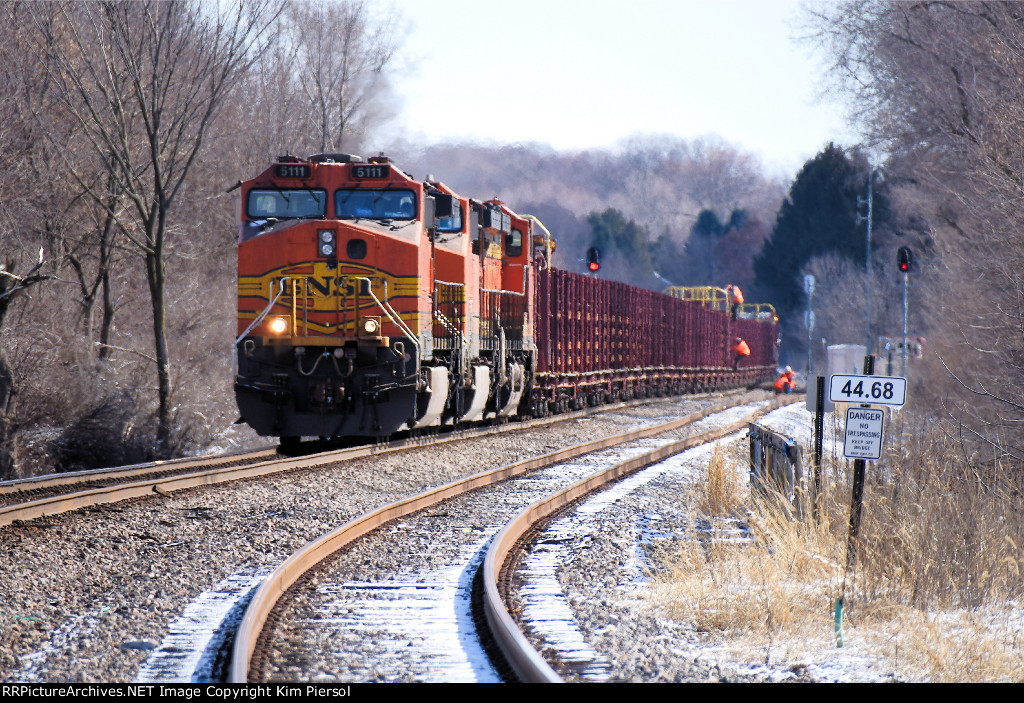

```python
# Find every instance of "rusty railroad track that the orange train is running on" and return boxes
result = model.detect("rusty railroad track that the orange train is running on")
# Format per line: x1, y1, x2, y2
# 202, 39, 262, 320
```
0, 394, 753, 527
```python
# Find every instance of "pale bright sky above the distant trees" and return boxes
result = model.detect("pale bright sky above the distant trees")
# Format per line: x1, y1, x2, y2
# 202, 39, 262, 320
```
376, 0, 858, 175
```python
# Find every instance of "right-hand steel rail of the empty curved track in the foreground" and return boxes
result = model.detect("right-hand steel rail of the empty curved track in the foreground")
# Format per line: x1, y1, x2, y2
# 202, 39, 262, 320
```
483, 396, 792, 684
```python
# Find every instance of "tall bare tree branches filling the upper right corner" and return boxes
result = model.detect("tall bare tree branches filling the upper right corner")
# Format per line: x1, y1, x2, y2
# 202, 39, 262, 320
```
816, 2, 1024, 466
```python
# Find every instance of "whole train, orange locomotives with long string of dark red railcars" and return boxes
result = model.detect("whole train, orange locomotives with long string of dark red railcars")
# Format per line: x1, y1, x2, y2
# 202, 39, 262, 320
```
234, 153, 777, 444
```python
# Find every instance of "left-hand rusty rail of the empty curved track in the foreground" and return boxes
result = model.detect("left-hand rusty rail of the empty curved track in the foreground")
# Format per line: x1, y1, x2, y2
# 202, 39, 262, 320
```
228, 393, 770, 684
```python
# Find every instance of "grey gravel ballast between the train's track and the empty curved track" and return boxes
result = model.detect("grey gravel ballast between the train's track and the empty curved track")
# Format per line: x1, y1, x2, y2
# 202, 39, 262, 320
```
0, 394, 790, 683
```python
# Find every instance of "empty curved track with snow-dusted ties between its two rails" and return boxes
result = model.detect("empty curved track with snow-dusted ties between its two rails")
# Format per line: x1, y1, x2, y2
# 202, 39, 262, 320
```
230, 396, 790, 683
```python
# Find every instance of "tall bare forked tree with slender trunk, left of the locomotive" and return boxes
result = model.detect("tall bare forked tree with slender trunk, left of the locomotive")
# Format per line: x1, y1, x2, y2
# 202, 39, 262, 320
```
33, 0, 281, 448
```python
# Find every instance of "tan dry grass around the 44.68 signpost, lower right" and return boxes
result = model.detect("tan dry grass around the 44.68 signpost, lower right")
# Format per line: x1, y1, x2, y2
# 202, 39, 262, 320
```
654, 429, 1024, 682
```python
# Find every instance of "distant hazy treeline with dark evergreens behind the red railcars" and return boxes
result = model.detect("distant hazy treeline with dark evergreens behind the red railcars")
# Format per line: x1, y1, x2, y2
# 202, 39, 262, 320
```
395, 137, 929, 368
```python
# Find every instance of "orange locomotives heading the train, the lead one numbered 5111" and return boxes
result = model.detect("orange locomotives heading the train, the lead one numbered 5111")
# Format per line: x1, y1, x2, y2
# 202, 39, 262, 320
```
236, 155, 536, 443
